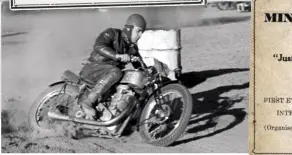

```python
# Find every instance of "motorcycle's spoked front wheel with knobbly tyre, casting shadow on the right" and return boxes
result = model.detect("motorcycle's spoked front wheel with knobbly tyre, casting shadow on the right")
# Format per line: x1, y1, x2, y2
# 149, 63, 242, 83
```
139, 84, 193, 146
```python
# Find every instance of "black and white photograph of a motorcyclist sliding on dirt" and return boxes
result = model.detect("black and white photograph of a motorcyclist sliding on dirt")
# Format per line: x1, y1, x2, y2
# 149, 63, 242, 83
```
1, 0, 252, 153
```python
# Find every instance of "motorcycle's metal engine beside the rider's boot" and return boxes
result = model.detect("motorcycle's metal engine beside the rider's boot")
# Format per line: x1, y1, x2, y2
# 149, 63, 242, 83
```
96, 85, 137, 121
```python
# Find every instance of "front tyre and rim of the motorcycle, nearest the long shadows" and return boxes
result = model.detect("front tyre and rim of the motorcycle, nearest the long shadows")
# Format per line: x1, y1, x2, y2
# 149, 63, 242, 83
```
139, 84, 193, 146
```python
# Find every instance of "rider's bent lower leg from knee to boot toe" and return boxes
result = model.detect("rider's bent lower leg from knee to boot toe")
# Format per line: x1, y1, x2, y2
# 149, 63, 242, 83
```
80, 66, 122, 119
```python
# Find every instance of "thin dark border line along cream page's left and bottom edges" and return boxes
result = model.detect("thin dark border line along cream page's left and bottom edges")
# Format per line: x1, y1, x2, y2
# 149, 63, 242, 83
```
251, 0, 292, 154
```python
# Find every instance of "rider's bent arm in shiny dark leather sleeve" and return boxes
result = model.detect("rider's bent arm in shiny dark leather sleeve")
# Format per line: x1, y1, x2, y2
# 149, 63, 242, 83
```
93, 28, 116, 60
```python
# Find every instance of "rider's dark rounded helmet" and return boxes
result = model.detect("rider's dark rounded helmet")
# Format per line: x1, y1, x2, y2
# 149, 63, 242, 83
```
126, 14, 147, 32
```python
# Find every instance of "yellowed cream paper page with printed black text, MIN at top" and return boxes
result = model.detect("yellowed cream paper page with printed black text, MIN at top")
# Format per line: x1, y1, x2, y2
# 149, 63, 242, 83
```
249, 0, 292, 154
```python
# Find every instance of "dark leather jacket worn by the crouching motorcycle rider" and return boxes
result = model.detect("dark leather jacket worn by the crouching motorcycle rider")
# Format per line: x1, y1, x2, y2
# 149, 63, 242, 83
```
88, 28, 140, 68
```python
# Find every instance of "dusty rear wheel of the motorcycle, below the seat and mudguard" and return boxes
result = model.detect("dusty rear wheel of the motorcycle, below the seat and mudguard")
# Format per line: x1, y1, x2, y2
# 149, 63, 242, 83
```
28, 83, 78, 132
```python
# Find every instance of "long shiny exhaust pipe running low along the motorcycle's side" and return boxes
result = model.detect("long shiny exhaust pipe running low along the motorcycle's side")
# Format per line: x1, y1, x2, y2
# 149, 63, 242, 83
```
48, 104, 135, 127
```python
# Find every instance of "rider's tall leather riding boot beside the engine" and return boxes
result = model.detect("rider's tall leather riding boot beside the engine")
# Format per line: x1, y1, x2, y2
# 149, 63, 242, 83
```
80, 73, 121, 120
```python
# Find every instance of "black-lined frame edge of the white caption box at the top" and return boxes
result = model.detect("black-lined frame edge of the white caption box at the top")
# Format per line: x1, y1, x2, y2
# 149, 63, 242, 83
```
9, 0, 207, 10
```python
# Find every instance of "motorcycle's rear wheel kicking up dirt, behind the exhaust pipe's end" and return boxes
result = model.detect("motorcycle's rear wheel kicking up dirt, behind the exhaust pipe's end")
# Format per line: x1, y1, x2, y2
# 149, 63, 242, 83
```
28, 83, 78, 132
